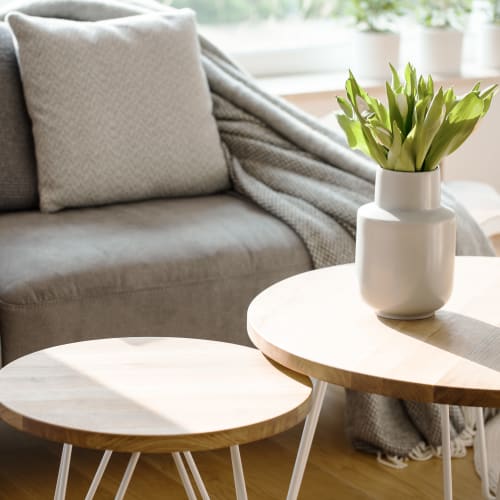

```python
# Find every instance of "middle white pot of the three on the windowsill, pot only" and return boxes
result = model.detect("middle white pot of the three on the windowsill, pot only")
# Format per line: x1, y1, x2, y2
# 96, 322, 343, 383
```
415, 27, 464, 75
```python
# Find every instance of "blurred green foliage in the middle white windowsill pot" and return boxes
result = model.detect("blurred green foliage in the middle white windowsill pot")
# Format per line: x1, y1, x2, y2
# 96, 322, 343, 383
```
415, 0, 472, 28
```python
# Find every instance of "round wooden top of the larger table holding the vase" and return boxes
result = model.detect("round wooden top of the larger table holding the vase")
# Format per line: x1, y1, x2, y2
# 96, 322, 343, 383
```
247, 257, 500, 407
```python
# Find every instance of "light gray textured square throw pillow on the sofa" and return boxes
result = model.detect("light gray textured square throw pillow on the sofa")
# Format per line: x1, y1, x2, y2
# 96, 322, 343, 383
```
7, 9, 229, 212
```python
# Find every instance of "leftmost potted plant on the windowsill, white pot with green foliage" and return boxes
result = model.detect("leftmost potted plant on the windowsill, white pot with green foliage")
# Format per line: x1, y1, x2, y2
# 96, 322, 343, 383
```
345, 0, 406, 80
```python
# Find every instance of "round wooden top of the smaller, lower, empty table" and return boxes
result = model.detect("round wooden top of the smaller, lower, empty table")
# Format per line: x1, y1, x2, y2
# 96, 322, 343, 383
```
0, 337, 311, 453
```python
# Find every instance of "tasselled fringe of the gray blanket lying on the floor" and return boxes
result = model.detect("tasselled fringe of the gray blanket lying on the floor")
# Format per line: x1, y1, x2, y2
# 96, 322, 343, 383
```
377, 424, 476, 469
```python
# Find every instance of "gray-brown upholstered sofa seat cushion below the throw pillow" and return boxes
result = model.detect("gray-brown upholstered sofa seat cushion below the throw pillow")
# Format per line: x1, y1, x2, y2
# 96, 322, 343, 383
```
0, 194, 311, 362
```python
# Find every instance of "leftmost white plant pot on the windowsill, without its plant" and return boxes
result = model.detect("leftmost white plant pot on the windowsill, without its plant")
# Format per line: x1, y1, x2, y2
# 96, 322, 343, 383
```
350, 31, 400, 81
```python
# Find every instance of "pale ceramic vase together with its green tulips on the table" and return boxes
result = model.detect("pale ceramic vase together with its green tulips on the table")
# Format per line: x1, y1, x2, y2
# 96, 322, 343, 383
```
338, 64, 497, 319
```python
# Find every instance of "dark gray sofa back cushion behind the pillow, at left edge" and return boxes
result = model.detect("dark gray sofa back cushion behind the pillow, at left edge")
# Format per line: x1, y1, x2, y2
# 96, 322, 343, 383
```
0, 22, 38, 211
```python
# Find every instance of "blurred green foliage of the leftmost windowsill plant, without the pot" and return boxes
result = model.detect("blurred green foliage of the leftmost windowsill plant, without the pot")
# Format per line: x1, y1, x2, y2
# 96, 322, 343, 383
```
342, 0, 407, 32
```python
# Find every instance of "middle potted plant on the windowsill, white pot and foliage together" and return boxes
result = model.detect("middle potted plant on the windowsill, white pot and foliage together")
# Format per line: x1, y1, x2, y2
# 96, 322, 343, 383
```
415, 0, 472, 75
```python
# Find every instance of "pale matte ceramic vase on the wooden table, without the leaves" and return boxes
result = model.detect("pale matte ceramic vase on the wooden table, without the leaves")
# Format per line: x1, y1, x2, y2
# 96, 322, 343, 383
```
356, 168, 456, 319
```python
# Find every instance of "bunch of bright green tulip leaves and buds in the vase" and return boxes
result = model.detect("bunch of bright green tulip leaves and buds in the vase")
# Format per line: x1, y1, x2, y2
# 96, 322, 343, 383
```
337, 63, 497, 172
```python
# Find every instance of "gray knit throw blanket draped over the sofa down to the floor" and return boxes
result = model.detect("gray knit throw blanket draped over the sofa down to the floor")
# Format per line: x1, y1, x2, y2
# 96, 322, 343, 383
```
0, 0, 493, 463
